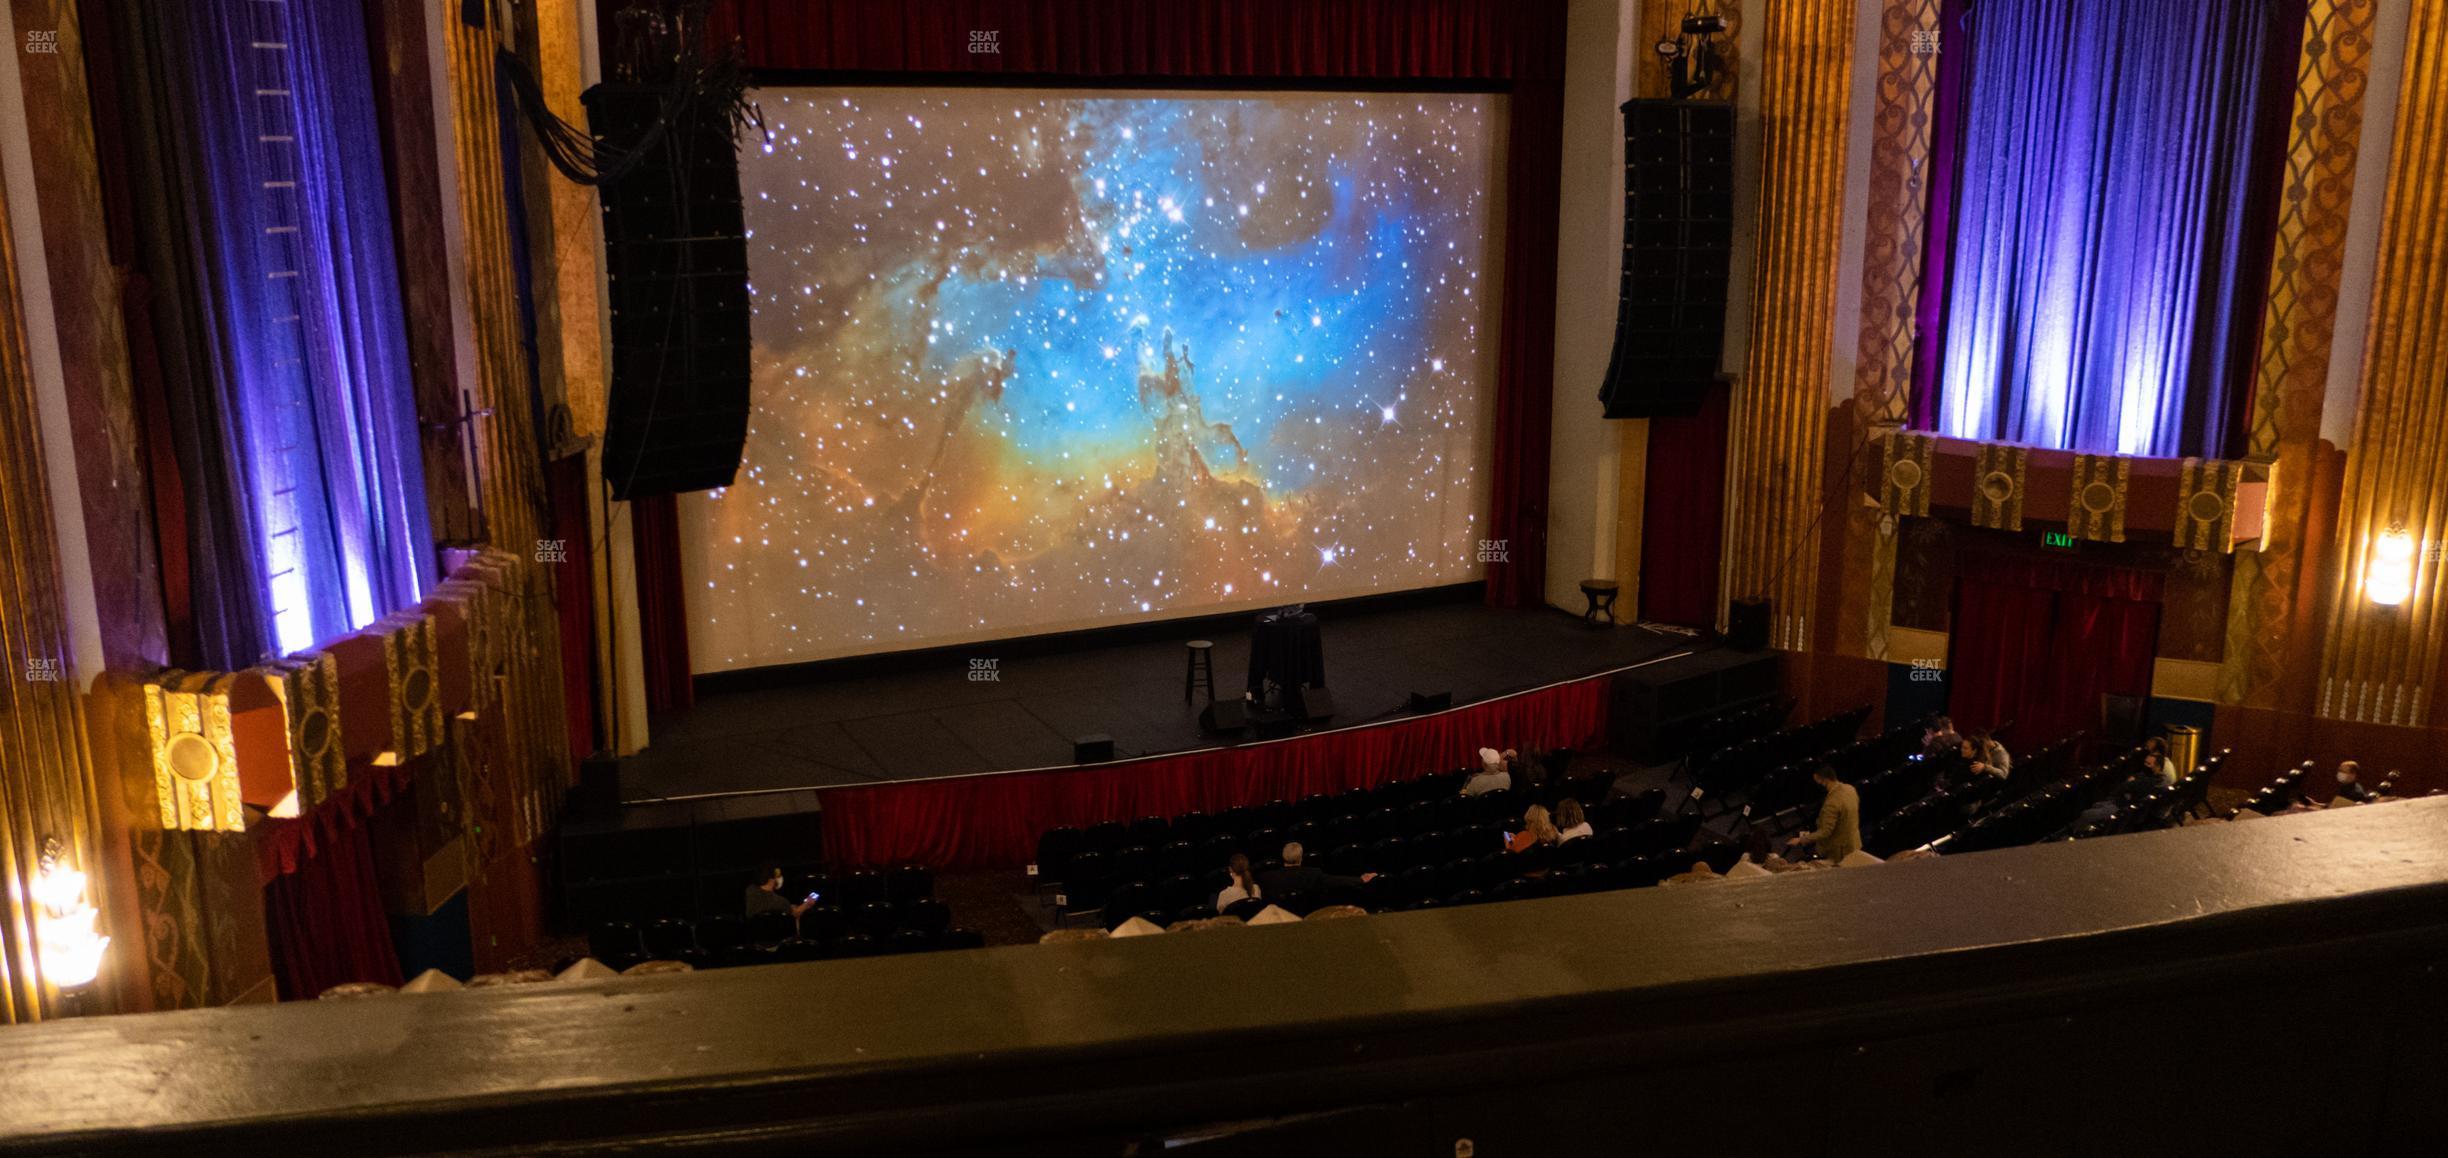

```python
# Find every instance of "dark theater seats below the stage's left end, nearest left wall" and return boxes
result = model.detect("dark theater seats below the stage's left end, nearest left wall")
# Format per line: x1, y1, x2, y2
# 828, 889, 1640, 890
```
588, 864, 984, 969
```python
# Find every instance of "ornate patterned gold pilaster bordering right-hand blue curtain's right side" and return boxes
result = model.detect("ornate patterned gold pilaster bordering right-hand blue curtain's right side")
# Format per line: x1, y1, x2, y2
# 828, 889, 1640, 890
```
2218, 0, 2377, 708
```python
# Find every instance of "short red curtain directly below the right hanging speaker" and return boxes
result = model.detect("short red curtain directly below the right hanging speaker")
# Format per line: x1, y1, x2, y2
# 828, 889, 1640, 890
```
1640, 382, 1733, 629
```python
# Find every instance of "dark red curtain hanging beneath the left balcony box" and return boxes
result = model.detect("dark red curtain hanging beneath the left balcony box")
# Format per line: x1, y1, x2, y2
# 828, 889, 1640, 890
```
264, 820, 399, 1001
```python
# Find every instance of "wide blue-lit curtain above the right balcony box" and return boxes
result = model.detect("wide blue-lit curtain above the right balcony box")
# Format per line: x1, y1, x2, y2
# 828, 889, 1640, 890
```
1919, 0, 2291, 455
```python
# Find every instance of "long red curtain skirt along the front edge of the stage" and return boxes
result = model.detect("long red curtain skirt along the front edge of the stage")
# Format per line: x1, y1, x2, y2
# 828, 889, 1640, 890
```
820, 676, 1613, 869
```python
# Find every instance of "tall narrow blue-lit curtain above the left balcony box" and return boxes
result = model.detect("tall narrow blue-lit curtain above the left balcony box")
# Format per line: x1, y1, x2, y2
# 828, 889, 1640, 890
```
164, 0, 436, 661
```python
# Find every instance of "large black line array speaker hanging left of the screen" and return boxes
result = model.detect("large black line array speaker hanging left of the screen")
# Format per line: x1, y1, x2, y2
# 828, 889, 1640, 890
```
585, 83, 749, 499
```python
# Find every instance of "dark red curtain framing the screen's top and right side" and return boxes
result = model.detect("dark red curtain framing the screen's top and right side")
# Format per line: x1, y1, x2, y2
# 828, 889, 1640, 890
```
690, 0, 1564, 607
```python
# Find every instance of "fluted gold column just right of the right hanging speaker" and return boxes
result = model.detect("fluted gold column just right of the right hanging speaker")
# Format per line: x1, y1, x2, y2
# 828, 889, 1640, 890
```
1718, 0, 1856, 649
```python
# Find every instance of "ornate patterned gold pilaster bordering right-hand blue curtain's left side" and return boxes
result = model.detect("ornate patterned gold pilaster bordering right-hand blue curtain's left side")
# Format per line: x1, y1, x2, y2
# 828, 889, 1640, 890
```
1836, 0, 1946, 659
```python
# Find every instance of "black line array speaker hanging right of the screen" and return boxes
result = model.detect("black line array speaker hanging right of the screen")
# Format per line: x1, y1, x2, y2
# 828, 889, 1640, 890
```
1599, 100, 1733, 419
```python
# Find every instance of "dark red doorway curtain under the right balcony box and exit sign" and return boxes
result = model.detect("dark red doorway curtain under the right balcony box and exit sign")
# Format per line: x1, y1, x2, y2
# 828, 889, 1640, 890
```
1946, 558, 2164, 747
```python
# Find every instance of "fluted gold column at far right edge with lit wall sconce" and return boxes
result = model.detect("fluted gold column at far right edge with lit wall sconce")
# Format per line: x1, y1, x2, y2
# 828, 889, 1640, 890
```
2318, 0, 2448, 725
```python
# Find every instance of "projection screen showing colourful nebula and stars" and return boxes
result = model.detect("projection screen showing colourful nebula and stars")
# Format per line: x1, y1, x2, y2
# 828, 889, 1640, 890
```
683, 88, 1501, 671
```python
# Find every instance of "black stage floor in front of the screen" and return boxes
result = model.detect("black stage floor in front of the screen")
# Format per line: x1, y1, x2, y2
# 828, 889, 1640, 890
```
619, 602, 1706, 803
